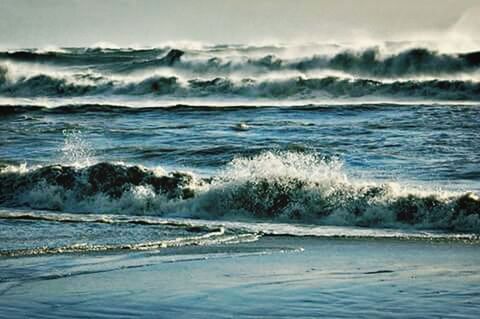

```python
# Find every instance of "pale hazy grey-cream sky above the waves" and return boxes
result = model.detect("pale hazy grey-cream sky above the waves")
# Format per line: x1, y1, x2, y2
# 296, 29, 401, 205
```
0, 0, 480, 47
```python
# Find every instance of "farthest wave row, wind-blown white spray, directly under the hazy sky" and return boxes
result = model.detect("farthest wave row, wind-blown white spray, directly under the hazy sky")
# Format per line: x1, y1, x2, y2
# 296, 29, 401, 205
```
0, 46, 480, 77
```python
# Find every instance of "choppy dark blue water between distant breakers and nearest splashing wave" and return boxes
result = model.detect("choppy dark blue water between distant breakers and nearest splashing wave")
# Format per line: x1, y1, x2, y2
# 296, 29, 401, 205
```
0, 104, 480, 190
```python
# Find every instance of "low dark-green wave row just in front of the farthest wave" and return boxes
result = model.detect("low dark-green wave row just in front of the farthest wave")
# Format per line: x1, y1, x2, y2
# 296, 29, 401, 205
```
0, 69, 480, 101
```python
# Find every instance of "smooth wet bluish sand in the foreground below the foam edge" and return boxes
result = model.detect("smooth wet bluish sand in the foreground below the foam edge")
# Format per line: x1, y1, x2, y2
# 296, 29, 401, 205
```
0, 236, 480, 318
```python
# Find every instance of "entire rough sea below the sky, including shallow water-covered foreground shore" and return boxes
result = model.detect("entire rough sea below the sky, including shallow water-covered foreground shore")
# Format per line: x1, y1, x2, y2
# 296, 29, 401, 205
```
0, 42, 480, 318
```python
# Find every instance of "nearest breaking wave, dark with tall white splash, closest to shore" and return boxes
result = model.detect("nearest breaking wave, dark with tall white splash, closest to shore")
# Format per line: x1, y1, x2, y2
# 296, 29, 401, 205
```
0, 152, 480, 234
